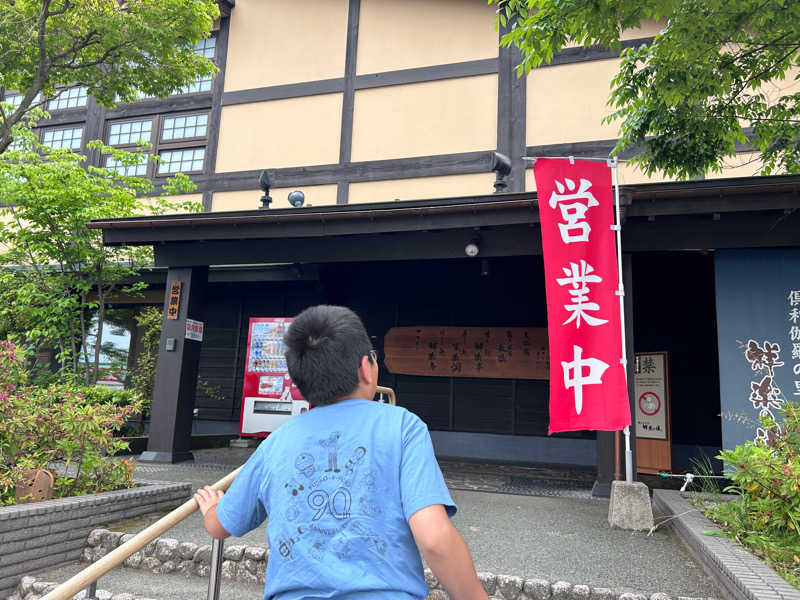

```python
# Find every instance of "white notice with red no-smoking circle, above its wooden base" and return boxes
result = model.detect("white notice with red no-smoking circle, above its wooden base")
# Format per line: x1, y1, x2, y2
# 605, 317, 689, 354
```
633, 352, 667, 440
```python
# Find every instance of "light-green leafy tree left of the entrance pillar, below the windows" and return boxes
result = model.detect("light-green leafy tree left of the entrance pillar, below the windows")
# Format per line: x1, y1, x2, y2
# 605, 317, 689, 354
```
0, 115, 202, 384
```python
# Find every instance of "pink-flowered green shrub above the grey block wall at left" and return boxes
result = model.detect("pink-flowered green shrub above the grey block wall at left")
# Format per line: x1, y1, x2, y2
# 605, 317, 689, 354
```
0, 342, 139, 504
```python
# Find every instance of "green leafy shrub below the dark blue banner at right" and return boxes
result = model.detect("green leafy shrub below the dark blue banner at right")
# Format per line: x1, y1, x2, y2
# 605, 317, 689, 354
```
710, 402, 800, 585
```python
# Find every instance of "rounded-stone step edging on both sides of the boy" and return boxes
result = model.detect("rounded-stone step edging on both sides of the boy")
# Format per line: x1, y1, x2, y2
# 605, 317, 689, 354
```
67, 529, 712, 600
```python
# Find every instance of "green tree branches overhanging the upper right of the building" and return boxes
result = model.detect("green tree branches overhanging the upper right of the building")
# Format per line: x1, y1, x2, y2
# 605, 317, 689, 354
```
489, 0, 800, 178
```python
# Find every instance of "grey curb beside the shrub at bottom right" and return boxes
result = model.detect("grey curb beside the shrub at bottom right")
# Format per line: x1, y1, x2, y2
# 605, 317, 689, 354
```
653, 490, 800, 600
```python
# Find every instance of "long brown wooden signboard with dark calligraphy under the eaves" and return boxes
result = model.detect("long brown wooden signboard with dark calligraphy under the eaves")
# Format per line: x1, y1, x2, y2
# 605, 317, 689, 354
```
383, 326, 550, 379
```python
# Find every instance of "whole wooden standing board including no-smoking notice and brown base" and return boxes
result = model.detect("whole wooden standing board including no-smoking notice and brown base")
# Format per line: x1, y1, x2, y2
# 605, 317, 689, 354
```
633, 352, 672, 473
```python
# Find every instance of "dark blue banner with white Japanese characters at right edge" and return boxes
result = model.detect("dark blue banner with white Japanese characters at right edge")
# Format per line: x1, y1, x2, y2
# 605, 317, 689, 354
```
714, 248, 800, 449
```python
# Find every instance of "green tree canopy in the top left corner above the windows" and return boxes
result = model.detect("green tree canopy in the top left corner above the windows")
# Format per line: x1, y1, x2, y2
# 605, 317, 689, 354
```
0, 0, 219, 152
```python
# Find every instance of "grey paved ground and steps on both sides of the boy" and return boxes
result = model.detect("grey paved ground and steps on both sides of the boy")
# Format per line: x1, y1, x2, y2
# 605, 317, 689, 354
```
28, 449, 722, 598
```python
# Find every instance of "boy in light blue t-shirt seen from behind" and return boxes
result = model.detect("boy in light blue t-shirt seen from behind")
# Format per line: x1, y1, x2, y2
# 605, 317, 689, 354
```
195, 306, 487, 600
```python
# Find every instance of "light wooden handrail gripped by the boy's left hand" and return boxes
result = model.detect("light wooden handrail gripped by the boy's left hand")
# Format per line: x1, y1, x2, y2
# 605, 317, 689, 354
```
42, 467, 241, 600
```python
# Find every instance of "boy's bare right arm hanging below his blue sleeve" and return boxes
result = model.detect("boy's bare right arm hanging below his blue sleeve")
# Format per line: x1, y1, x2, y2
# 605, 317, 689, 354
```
408, 504, 487, 600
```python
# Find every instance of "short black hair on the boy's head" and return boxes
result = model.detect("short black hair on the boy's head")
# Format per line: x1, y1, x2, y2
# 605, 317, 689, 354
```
283, 304, 372, 406
